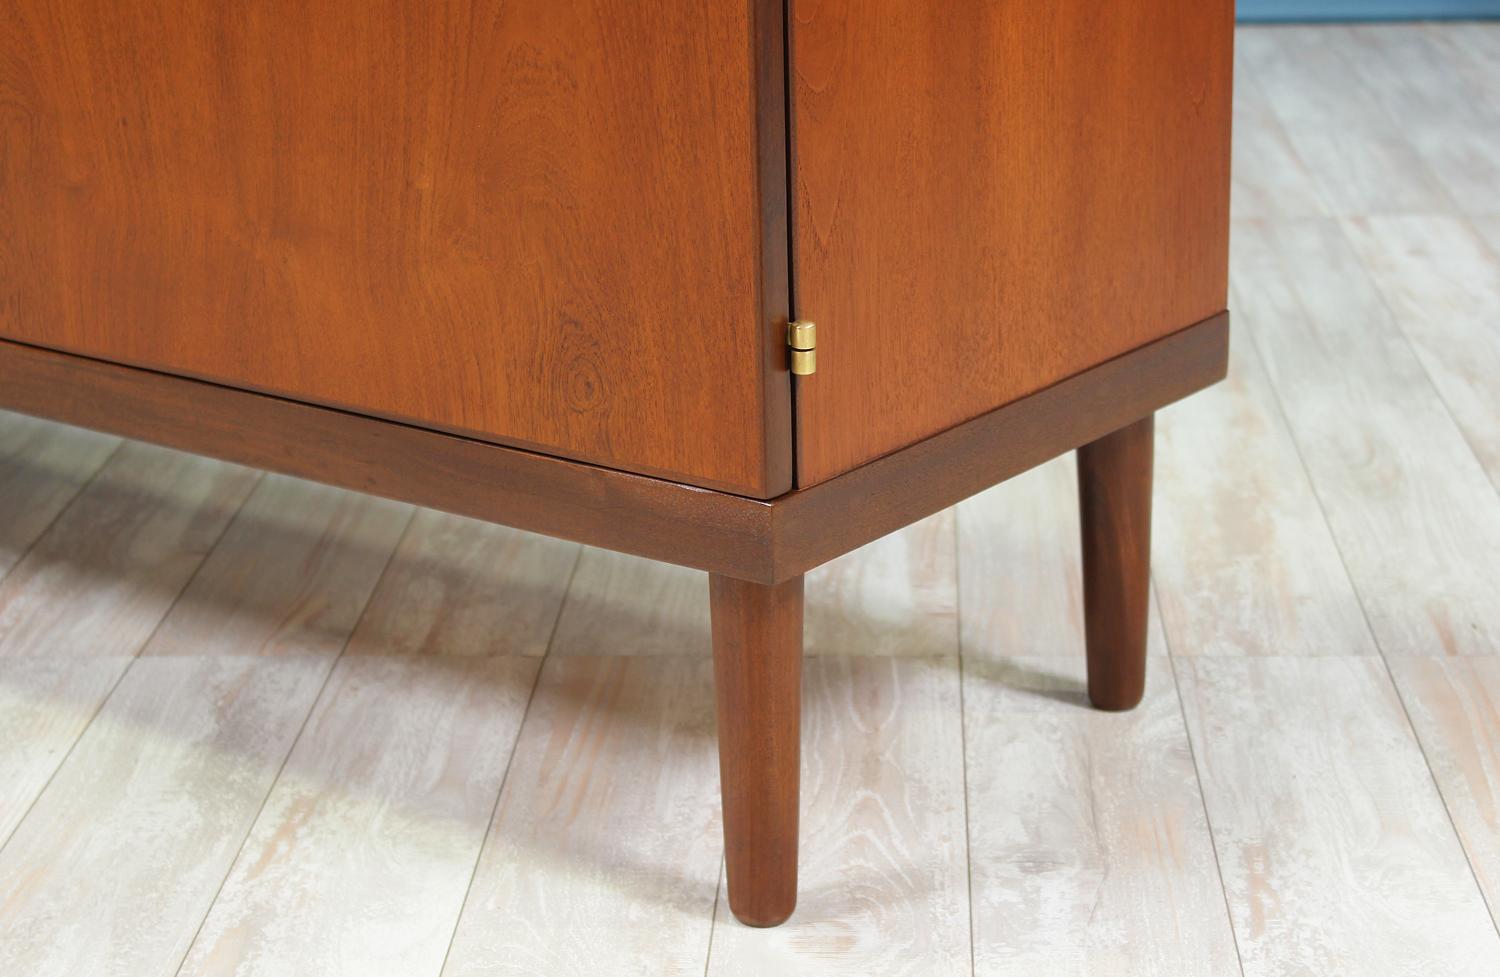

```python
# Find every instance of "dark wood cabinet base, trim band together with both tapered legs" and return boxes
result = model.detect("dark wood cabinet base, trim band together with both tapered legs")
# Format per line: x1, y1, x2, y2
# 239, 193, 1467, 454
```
0, 314, 1229, 926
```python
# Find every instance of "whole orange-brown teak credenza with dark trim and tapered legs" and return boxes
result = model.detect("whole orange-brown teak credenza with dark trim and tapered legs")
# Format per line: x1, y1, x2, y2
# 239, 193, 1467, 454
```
0, 0, 1233, 926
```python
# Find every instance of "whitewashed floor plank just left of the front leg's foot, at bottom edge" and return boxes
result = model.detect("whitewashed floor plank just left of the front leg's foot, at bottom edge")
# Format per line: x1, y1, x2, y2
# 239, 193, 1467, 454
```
443, 656, 723, 977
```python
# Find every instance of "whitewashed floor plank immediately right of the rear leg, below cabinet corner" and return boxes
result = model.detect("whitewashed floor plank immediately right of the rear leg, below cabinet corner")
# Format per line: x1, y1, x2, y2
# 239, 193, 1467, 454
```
1152, 330, 1376, 657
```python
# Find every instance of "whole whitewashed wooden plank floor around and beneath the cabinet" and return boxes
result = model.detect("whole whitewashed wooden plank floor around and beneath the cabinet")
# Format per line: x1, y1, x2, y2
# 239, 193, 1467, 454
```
0, 26, 1500, 977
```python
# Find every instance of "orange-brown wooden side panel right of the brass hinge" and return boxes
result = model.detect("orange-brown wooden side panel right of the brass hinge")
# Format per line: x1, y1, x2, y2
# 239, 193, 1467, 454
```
789, 0, 1233, 485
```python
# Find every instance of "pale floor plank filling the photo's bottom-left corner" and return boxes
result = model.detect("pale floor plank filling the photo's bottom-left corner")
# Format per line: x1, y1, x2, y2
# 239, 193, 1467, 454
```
0, 656, 329, 977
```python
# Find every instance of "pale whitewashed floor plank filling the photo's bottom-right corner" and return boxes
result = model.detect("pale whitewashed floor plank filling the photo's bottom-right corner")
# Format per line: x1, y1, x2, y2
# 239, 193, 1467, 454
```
1176, 657, 1500, 977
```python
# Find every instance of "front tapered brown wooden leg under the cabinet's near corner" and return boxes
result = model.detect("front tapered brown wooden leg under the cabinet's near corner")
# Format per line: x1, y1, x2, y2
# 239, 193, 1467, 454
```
708, 573, 803, 926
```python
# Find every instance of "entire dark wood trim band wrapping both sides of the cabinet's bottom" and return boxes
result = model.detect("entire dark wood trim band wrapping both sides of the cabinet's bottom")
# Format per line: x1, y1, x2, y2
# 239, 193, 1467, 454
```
0, 314, 1229, 584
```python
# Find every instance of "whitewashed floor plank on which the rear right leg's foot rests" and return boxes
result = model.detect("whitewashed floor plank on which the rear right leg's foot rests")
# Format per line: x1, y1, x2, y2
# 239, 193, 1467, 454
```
963, 657, 1239, 977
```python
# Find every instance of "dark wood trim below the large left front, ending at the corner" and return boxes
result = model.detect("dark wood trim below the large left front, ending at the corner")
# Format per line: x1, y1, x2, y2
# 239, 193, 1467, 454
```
0, 341, 771, 579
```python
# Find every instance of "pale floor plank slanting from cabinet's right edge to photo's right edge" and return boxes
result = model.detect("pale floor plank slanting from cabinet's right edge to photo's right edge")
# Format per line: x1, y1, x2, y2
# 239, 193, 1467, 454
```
1232, 221, 1500, 656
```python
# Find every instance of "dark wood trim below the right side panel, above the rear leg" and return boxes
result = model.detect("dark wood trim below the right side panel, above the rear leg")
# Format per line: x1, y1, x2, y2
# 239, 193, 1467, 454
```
771, 312, 1229, 579
